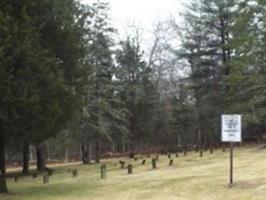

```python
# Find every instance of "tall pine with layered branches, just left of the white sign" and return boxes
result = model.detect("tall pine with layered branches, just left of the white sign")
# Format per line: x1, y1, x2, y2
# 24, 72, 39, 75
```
174, 0, 237, 149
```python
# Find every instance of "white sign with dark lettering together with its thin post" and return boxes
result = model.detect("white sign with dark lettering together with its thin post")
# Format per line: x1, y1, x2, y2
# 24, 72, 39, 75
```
222, 115, 241, 186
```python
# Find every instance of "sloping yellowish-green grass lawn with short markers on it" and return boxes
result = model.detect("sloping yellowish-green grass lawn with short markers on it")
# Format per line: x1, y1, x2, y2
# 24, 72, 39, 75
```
0, 147, 266, 200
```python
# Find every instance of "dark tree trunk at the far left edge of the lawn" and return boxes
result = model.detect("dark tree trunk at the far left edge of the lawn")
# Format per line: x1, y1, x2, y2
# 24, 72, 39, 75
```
0, 133, 8, 194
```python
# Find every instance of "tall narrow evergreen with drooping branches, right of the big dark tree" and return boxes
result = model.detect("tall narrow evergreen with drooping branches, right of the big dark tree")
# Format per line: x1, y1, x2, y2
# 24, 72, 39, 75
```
79, 1, 125, 162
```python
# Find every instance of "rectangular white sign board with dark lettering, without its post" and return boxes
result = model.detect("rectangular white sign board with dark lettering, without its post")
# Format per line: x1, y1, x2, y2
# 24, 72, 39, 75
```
222, 115, 241, 142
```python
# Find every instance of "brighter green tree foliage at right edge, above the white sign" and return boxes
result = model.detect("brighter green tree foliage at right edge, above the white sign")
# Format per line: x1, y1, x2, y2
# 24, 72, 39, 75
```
226, 1, 266, 132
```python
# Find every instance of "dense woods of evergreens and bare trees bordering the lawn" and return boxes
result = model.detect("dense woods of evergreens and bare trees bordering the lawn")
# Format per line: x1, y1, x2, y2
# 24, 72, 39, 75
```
0, 0, 266, 193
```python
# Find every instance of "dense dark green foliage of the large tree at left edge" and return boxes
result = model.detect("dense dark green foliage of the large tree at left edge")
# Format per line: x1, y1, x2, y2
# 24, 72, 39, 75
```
0, 0, 90, 192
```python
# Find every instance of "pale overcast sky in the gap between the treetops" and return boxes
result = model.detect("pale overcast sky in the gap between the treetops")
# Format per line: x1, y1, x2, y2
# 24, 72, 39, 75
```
83, 0, 188, 44
